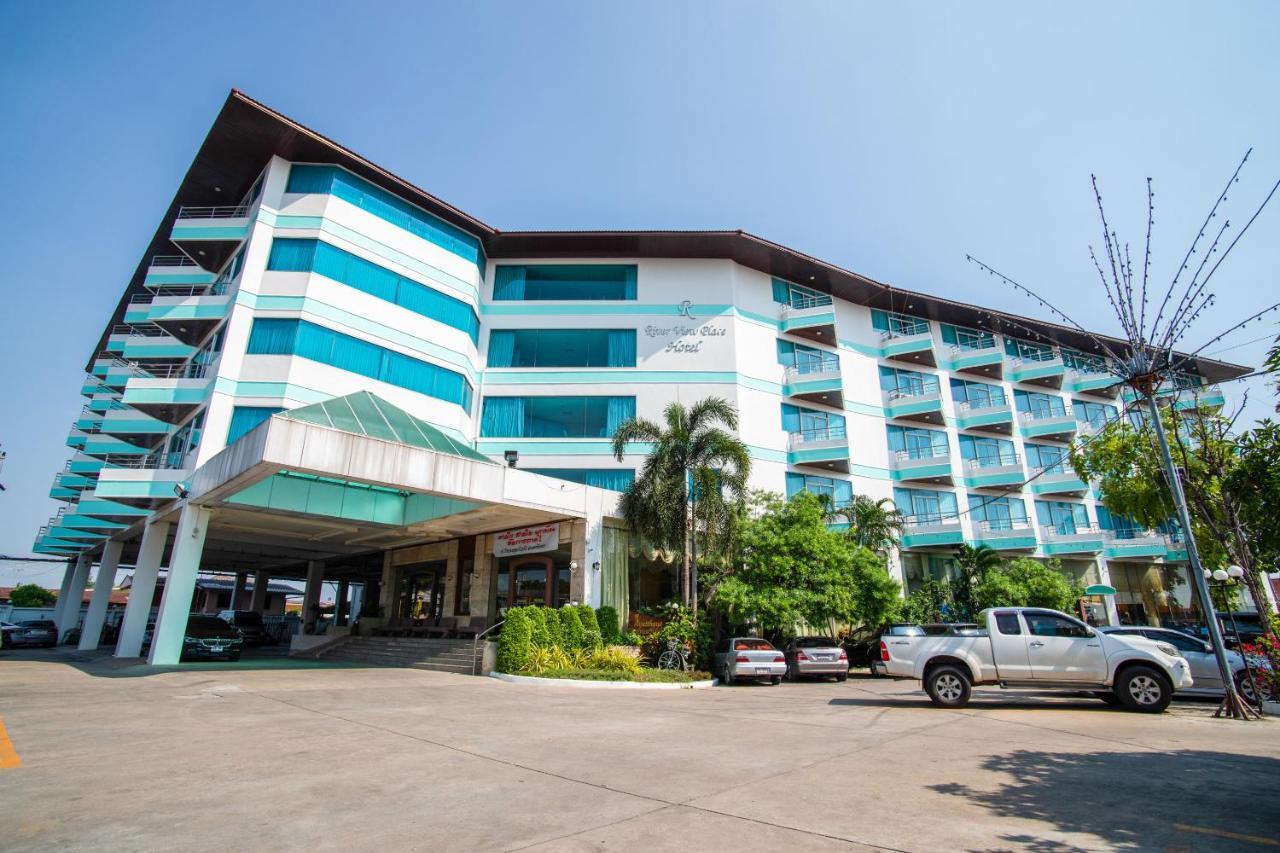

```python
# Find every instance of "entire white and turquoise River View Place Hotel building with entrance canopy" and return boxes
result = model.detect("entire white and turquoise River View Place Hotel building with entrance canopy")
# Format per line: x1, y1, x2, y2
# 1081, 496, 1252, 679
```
35, 91, 1245, 662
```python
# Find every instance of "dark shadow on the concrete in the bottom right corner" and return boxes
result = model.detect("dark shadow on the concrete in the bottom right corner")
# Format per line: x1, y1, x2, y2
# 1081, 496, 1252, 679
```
929, 747, 1280, 852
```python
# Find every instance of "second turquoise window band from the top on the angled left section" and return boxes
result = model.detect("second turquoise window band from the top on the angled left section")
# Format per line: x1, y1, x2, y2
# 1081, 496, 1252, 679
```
266, 237, 480, 342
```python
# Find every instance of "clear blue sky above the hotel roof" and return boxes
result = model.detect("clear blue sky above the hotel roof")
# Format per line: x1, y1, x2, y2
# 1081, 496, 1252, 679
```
0, 1, 1280, 585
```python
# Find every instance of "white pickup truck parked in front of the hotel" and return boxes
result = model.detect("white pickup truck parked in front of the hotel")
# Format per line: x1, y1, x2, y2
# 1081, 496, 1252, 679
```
879, 607, 1192, 713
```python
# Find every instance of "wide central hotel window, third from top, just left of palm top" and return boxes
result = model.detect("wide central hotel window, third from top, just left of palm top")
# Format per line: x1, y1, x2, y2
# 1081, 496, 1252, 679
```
480, 397, 636, 438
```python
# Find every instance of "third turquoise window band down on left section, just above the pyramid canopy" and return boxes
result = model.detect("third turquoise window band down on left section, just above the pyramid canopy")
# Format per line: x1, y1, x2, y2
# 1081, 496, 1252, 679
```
246, 318, 471, 410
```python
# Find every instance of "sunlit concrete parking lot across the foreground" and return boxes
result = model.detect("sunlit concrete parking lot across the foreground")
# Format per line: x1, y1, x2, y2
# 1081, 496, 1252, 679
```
0, 651, 1280, 853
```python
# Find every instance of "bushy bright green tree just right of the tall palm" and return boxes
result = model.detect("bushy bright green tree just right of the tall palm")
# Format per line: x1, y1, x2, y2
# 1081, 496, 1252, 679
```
710, 492, 899, 630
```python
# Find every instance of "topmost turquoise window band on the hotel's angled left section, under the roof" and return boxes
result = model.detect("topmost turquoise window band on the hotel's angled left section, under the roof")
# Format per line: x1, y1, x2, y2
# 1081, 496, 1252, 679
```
284, 164, 484, 262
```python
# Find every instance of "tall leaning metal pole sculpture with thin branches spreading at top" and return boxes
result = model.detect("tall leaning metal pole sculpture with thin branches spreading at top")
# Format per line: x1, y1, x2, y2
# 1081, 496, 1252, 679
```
966, 149, 1280, 720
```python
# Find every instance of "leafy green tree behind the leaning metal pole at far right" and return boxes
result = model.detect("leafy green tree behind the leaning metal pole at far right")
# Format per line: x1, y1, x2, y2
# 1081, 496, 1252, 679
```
1071, 407, 1280, 628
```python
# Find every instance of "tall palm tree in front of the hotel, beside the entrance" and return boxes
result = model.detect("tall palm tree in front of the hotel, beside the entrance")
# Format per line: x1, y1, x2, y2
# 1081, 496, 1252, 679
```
613, 397, 751, 606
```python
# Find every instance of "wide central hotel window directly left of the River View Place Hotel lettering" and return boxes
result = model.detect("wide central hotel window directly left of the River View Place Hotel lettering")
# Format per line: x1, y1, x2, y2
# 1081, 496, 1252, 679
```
489, 329, 636, 368
